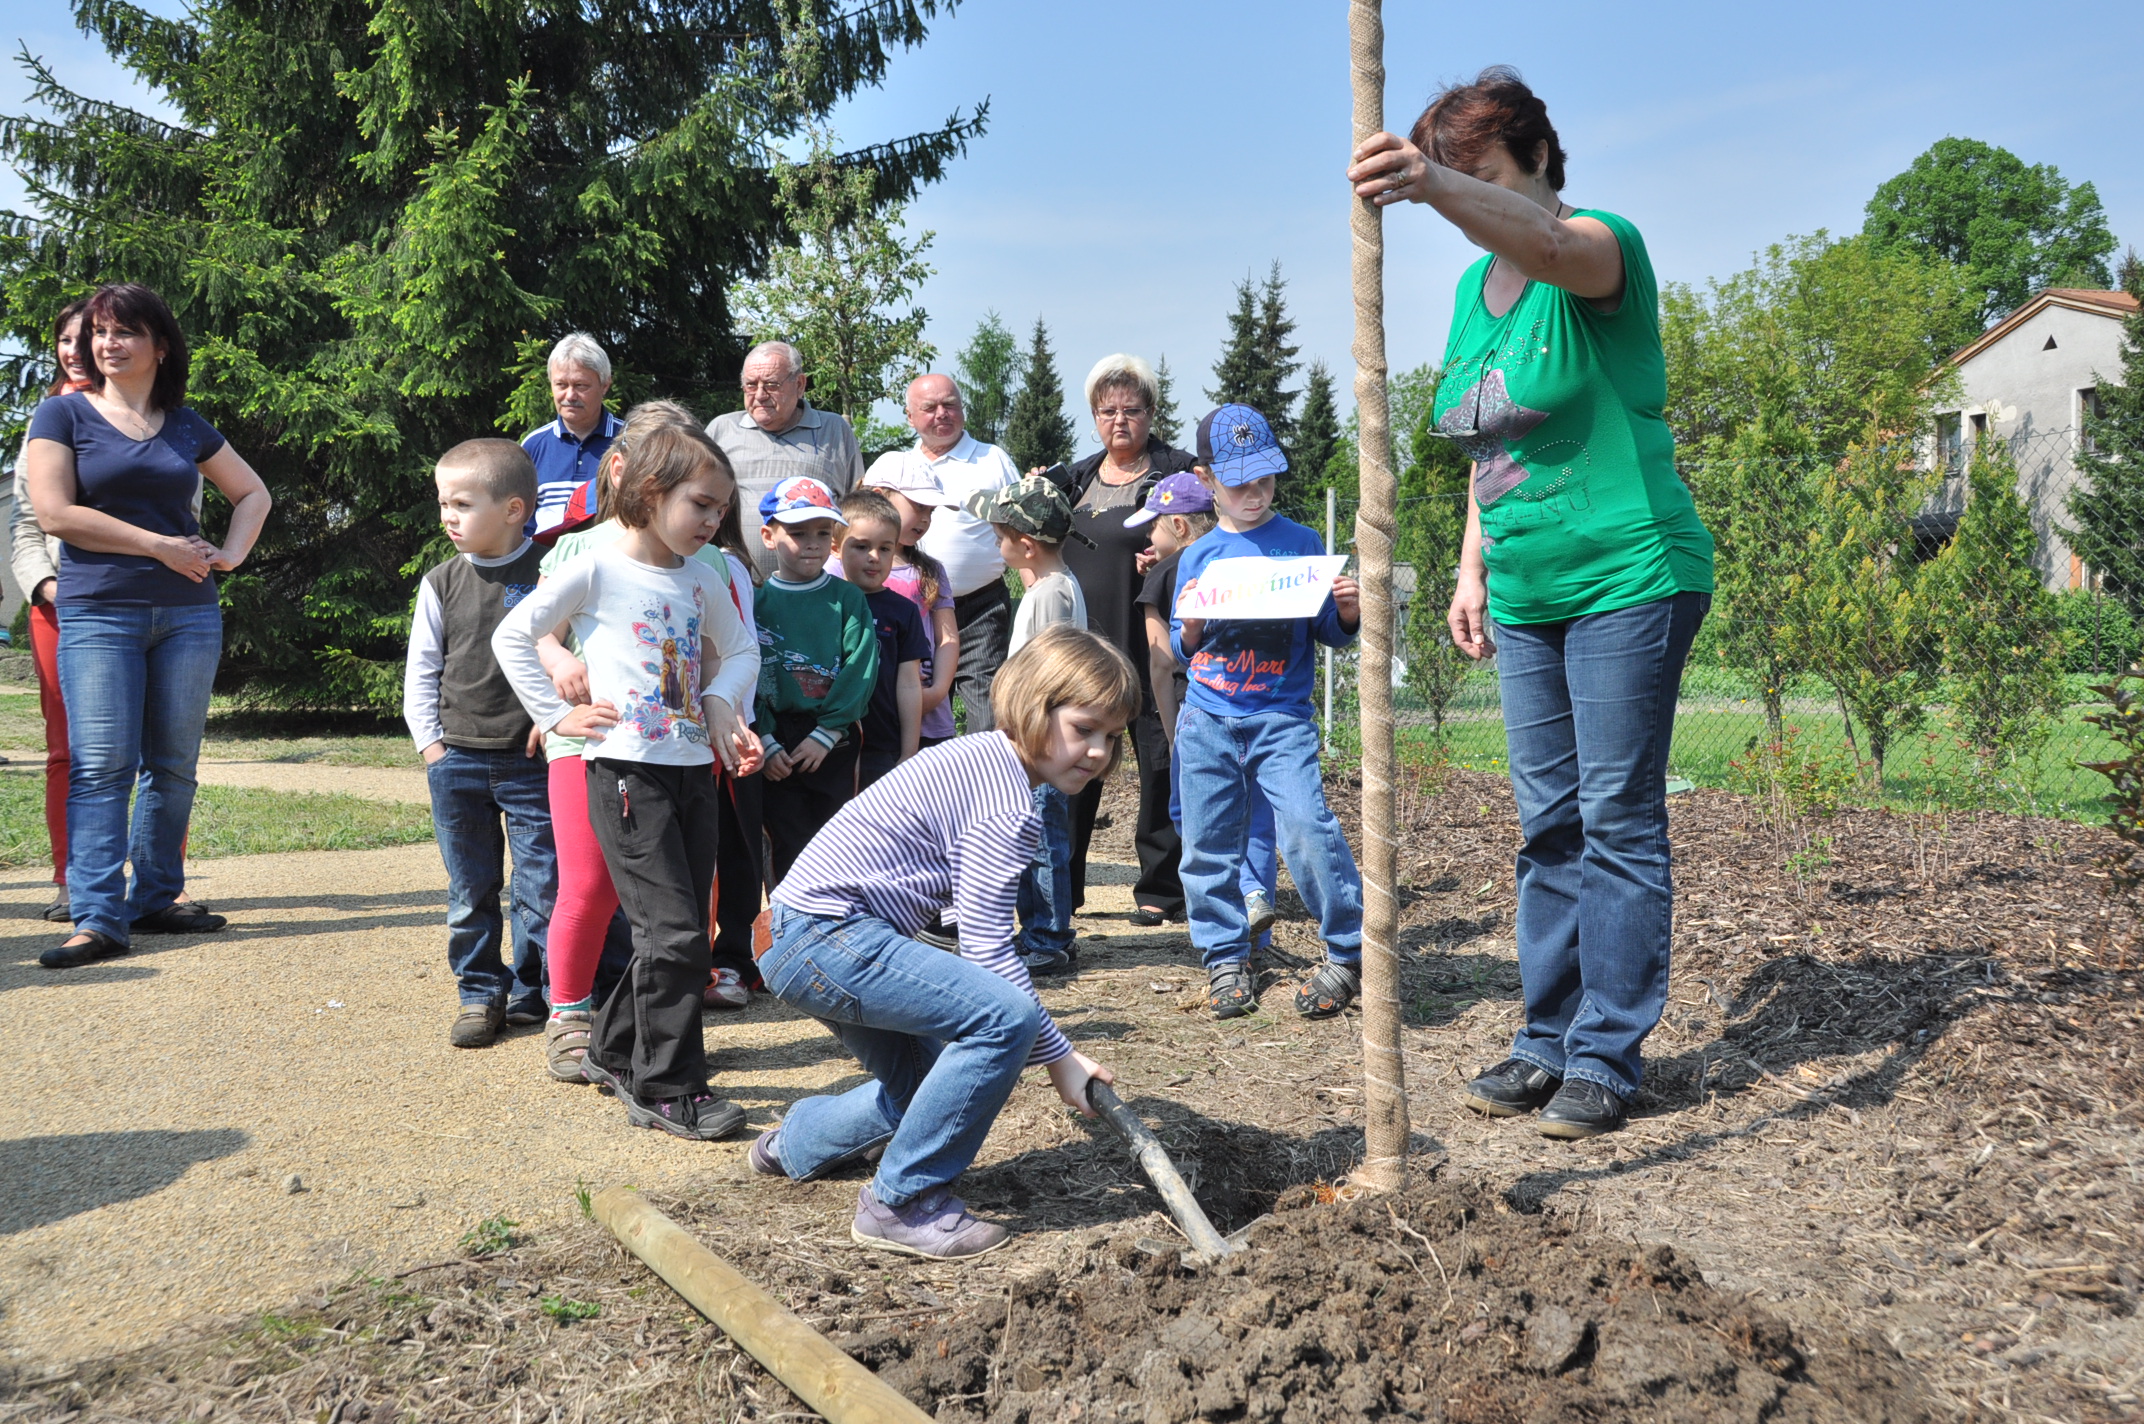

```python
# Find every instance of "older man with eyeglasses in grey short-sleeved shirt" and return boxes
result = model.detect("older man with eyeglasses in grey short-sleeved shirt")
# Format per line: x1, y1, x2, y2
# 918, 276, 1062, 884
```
708, 341, 864, 575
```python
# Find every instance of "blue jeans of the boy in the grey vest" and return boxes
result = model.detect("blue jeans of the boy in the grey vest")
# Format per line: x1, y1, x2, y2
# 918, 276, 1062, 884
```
425, 746, 557, 1012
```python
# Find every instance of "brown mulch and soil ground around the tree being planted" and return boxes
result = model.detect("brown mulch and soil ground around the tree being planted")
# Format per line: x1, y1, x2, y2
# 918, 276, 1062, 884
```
0, 774, 2144, 1424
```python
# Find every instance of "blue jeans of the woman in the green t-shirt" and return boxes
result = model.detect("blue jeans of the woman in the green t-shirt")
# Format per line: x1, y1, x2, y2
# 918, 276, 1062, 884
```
1494, 594, 1713, 1098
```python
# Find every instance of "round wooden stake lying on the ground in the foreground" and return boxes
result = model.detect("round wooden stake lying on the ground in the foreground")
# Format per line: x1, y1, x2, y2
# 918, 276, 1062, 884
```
590, 1186, 930, 1424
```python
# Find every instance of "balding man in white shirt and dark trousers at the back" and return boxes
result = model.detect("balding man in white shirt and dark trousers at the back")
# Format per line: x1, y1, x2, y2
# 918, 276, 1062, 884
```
864, 375, 1021, 731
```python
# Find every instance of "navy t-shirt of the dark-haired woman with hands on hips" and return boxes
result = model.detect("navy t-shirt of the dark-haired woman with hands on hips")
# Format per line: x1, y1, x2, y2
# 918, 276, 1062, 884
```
28, 390, 223, 607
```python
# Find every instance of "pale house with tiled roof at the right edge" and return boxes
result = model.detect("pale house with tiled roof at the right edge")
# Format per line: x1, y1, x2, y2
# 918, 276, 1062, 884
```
1921, 287, 2138, 588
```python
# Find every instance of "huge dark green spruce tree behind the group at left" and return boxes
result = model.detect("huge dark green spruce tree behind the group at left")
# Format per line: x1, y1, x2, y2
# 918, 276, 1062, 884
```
0, 0, 982, 706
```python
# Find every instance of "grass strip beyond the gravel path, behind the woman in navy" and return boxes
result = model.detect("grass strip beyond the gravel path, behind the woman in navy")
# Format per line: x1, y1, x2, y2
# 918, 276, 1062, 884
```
0, 766, 431, 866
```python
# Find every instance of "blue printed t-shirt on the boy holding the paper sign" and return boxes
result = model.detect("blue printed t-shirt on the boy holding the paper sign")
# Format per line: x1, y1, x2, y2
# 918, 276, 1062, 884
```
1168, 515, 1355, 716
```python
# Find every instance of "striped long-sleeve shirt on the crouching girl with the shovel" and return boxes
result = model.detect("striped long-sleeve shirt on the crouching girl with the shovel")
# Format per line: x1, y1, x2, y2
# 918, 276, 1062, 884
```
774, 731, 1072, 1068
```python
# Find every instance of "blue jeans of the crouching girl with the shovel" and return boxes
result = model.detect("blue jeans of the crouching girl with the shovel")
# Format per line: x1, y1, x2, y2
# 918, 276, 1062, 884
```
759, 903, 1042, 1207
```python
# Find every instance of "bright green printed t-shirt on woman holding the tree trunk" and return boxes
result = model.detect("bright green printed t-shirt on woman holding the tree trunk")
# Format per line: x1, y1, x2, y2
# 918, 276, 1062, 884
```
1434, 208, 1713, 624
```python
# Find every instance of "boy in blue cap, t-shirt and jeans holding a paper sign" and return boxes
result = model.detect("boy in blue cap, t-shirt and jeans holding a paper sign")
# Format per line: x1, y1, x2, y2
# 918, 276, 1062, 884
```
1171, 405, 1361, 1019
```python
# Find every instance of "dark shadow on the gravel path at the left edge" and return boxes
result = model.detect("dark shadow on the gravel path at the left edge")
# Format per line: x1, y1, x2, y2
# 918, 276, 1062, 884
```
0, 1128, 253, 1235
